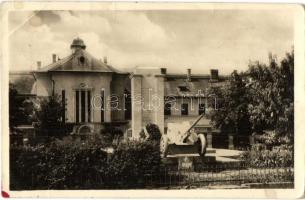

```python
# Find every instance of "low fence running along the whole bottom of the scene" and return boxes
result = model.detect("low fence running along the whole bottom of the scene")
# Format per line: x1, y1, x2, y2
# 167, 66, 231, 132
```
11, 163, 294, 190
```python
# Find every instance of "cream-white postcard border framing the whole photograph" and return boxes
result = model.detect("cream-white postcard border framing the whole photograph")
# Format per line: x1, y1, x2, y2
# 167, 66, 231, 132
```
1, 2, 305, 198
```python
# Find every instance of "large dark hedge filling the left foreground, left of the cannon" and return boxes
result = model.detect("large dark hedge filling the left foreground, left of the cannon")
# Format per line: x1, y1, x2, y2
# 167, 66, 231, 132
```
10, 139, 161, 190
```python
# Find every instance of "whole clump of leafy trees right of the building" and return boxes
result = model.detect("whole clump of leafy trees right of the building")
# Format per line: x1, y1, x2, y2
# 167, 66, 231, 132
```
209, 51, 294, 141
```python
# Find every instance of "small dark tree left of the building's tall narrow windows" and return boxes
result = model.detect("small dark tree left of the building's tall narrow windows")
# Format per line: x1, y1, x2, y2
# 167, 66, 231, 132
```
36, 95, 64, 136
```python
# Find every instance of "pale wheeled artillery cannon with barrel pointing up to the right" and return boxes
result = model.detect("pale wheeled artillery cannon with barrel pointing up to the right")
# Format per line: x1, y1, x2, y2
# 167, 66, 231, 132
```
160, 114, 207, 158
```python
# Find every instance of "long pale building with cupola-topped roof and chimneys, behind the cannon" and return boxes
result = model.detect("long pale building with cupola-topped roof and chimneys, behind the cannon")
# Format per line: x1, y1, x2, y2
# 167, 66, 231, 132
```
9, 38, 224, 138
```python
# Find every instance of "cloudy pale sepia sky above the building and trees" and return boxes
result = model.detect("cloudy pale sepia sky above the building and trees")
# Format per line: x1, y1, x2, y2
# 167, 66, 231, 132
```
9, 9, 294, 74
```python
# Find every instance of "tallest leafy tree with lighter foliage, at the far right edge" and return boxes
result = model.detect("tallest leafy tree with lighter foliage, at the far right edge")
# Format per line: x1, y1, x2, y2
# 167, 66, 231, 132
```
247, 51, 294, 136
